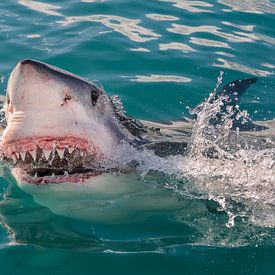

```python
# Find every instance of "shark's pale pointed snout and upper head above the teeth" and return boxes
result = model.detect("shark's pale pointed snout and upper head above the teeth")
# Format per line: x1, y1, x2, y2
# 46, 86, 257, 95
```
2, 59, 124, 161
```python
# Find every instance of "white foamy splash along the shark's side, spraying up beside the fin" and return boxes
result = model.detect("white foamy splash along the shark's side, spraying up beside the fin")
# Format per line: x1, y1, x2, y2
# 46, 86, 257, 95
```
112, 72, 275, 232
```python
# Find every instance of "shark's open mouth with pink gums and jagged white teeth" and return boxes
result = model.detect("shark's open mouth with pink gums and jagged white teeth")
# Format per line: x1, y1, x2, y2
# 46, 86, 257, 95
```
1, 137, 105, 184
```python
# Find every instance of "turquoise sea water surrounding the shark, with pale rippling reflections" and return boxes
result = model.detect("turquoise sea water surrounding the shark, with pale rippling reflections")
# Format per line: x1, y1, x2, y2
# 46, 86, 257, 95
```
0, 0, 275, 274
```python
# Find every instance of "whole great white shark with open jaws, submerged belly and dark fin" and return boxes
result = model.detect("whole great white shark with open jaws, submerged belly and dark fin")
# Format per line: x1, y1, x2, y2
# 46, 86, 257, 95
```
1, 60, 268, 222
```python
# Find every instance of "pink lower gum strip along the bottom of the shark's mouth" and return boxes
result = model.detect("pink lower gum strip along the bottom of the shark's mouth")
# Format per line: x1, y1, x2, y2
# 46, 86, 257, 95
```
12, 168, 101, 185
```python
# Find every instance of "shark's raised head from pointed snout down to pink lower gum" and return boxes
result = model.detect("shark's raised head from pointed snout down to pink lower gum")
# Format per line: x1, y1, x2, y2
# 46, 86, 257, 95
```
1, 60, 125, 183
